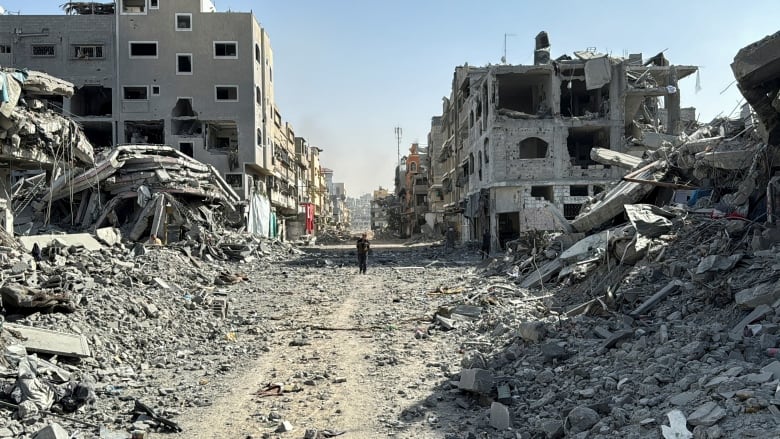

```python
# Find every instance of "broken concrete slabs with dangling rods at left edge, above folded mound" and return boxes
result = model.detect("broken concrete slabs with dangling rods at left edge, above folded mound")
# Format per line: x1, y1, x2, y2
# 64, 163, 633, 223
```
0, 68, 94, 167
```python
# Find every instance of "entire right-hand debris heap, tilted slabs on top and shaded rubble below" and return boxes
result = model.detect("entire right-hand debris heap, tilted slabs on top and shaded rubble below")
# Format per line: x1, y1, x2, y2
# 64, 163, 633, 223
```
435, 33, 780, 439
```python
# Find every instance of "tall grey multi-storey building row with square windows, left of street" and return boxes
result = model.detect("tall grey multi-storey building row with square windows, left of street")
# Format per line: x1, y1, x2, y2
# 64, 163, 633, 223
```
0, 0, 332, 241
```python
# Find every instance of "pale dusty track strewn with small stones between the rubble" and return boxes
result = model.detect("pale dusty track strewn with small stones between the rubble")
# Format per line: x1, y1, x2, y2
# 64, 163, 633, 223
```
168, 243, 479, 438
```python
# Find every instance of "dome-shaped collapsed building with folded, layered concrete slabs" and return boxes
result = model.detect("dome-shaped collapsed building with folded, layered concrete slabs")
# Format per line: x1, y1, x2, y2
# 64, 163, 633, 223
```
22, 145, 240, 242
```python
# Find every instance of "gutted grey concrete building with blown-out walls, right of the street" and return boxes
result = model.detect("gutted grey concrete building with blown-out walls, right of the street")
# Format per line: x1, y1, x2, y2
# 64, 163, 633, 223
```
429, 32, 697, 248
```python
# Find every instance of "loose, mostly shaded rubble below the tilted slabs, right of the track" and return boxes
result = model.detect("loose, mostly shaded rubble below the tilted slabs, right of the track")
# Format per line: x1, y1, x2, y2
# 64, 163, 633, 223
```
426, 211, 780, 438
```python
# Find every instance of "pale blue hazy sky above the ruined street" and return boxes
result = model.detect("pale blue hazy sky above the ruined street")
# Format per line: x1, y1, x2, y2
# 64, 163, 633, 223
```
0, 0, 780, 196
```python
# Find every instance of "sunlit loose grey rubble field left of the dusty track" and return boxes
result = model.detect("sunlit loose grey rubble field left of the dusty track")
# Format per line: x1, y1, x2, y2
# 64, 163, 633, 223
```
0, 236, 294, 437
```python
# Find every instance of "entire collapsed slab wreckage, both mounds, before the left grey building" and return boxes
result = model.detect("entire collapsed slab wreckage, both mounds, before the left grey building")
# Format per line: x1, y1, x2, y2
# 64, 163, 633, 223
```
0, 69, 243, 242
